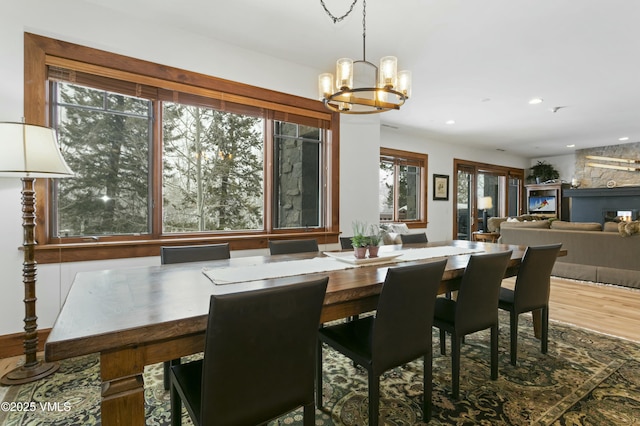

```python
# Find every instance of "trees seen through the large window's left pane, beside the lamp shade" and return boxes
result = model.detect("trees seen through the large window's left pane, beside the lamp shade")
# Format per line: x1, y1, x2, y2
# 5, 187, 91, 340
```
58, 83, 150, 235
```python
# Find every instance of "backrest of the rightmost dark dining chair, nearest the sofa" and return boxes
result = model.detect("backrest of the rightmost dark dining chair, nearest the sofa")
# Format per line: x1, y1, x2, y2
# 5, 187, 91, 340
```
513, 244, 562, 312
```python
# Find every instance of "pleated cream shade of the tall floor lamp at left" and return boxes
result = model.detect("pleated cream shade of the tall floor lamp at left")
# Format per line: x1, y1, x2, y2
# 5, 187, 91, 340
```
0, 122, 73, 178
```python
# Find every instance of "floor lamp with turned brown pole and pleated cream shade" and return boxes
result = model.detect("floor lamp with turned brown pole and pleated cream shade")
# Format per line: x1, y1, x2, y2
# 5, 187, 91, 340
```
0, 122, 73, 385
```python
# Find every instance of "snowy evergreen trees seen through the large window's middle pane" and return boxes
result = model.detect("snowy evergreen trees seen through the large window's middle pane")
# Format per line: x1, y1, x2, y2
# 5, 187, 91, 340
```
163, 103, 263, 232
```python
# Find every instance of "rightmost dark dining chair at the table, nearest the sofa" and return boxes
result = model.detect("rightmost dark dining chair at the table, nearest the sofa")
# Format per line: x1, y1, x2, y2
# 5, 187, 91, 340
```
498, 244, 562, 365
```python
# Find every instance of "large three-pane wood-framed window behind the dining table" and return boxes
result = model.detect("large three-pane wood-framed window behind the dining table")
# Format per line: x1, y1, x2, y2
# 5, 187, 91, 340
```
25, 34, 339, 263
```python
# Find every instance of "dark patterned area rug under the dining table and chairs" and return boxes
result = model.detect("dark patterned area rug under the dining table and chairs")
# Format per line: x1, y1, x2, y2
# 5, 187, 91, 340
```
0, 315, 640, 426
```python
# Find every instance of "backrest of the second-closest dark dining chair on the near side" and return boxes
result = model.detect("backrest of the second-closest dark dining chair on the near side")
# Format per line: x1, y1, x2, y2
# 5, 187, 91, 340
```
371, 259, 447, 375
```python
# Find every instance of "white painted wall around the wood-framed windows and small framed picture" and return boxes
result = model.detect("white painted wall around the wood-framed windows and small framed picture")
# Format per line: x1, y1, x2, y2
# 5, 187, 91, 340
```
0, 0, 529, 335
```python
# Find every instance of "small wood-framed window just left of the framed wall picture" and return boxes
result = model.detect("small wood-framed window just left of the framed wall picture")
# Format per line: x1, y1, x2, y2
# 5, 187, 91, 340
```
379, 148, 428, 227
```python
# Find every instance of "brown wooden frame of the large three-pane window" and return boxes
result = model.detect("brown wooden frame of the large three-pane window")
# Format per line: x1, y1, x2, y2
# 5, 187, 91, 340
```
24, 33, 340, 263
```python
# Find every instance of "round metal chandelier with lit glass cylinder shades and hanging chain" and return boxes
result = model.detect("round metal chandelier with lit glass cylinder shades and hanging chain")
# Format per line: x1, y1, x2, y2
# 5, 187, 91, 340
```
318, 0, 411, 114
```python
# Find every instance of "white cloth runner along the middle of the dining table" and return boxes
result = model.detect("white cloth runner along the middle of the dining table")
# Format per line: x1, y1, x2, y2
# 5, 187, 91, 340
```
202, 246, 483, 285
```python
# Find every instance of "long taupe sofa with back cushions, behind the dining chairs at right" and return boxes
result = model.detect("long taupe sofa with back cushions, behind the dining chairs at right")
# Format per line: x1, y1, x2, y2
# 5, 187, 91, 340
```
498, 220, 640, 288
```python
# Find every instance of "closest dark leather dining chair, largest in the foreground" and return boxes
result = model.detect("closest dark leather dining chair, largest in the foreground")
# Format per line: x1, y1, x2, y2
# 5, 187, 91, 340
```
171, 277, 328, 426
